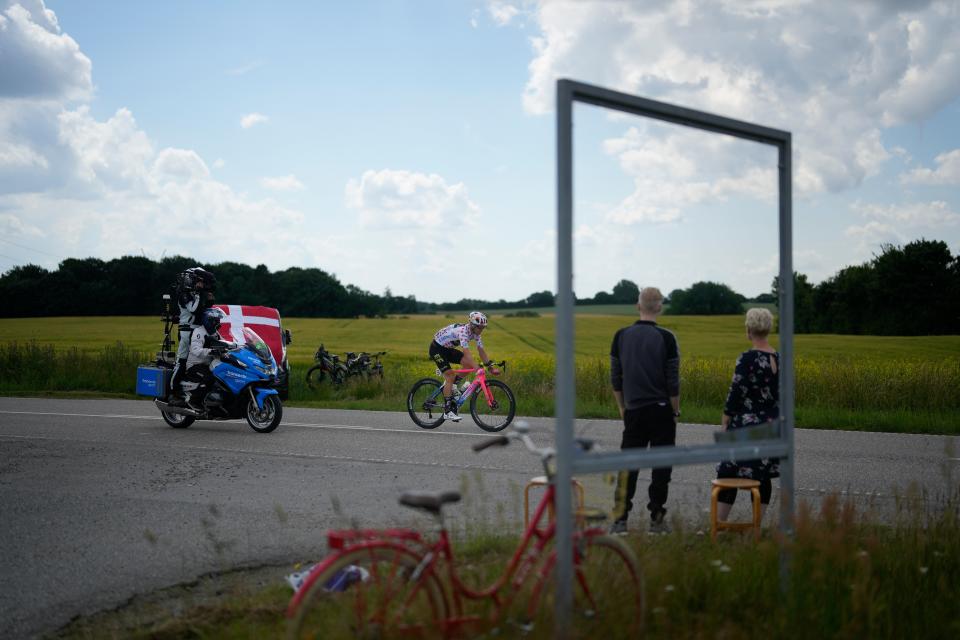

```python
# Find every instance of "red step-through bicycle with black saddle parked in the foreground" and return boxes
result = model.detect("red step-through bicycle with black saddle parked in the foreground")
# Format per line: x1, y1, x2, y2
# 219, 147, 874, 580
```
287, 423, 644, 638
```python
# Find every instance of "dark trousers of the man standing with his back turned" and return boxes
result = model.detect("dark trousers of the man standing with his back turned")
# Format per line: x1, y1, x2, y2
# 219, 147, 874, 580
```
613, 403, 677, 520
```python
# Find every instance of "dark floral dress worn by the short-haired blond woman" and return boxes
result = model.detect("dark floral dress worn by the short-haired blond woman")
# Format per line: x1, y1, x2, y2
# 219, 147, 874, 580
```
717, 349, 780, 481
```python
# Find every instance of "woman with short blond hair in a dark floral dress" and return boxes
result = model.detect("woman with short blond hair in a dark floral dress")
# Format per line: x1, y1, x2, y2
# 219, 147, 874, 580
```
717, 308, 780, 521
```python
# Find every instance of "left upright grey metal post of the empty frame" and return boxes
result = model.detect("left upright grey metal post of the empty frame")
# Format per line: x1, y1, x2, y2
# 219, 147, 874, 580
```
554, 80, 576, 638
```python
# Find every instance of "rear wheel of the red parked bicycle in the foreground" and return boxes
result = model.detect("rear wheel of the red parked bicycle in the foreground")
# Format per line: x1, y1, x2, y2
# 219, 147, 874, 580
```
287, 542, 447, 640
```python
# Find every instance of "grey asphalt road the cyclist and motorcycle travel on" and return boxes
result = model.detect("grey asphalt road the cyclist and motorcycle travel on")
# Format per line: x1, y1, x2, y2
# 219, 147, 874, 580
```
0, 398, 960, 638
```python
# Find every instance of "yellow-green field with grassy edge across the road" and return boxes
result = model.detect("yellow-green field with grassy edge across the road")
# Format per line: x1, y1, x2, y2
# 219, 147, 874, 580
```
0, 314, 960, 433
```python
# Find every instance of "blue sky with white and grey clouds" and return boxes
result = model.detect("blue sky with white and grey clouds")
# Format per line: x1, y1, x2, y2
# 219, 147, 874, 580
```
0, 0, 960, 302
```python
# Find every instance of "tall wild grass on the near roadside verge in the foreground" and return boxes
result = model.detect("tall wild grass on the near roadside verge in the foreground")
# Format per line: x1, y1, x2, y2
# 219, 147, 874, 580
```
58, 488, 960, 640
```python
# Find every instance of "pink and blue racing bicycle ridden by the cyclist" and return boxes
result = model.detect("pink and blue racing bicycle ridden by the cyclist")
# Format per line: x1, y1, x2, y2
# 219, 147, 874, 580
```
407, 360, 517, 432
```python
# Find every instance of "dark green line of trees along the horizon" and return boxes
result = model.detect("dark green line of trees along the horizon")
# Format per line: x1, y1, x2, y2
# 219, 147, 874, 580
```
0, 240, 960, 335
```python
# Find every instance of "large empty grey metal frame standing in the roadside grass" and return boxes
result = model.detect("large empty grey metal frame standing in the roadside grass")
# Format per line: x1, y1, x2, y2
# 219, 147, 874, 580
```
554, 79, 794, 637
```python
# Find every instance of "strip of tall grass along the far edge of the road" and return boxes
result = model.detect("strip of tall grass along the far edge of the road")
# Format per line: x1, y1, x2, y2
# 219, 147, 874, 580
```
0, 342, 960, 433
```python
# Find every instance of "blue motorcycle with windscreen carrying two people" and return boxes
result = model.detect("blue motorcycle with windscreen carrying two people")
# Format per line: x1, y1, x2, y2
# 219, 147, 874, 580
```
154, 327, 283, 433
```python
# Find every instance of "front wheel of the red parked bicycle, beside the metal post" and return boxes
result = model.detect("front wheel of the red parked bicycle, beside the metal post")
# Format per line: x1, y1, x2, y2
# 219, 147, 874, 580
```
528, 531, 646, 638
